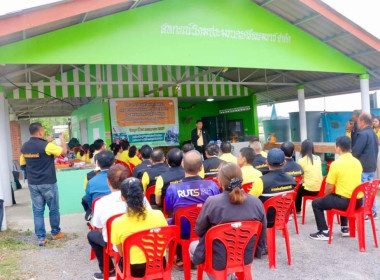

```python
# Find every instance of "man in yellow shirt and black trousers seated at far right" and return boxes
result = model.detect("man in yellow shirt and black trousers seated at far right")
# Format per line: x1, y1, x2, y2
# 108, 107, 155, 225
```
310, 136, 362, 240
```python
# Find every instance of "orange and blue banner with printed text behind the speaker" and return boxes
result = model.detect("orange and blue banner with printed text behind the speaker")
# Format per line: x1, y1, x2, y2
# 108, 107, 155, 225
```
110, 98, 179, 147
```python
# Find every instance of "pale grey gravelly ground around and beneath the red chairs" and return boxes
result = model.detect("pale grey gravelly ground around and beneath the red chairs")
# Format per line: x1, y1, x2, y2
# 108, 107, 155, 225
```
0, 184, 380, 280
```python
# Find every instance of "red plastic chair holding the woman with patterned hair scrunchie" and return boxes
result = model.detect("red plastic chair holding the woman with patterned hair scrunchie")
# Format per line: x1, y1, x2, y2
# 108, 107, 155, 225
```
197, 221, 262, 280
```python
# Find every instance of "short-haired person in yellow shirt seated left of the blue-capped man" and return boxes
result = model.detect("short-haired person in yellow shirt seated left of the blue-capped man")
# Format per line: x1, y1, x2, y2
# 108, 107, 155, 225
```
238, 148, 263, 185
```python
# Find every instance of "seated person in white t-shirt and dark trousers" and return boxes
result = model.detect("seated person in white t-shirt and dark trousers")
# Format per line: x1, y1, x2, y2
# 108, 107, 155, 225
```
87, 164, 151, 279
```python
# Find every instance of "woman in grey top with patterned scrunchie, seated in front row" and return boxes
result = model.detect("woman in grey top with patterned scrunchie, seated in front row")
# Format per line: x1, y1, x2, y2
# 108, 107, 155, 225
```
190, 163, 266, 270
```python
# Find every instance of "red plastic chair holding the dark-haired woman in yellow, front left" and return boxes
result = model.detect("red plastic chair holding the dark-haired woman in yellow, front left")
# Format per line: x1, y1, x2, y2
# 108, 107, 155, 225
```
115, 226, 179, 280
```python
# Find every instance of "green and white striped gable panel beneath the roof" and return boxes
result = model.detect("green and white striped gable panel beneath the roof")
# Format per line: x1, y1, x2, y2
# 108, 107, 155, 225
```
7, 65, 249, 99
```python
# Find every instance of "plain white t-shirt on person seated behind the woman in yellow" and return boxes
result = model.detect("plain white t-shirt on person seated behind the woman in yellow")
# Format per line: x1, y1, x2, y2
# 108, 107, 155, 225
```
91, 191, 152, 242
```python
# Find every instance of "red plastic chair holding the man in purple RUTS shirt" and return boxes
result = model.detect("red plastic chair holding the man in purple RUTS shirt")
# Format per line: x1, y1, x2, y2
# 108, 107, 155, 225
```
174, 203, 203, 280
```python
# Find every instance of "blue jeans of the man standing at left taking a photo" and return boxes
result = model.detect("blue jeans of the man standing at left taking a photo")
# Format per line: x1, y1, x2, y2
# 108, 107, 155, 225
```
28, 183, 61, 240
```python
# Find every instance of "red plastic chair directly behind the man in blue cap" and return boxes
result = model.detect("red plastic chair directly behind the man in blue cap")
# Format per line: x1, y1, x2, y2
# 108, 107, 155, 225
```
264, 192, 294, 269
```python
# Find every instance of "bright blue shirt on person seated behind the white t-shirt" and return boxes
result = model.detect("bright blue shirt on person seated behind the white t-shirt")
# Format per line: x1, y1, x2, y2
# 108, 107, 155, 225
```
86, 170, 111, 210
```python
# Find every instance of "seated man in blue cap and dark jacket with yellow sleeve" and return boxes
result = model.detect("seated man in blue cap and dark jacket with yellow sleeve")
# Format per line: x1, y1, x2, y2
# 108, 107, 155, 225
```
249, 148, 296, 227
